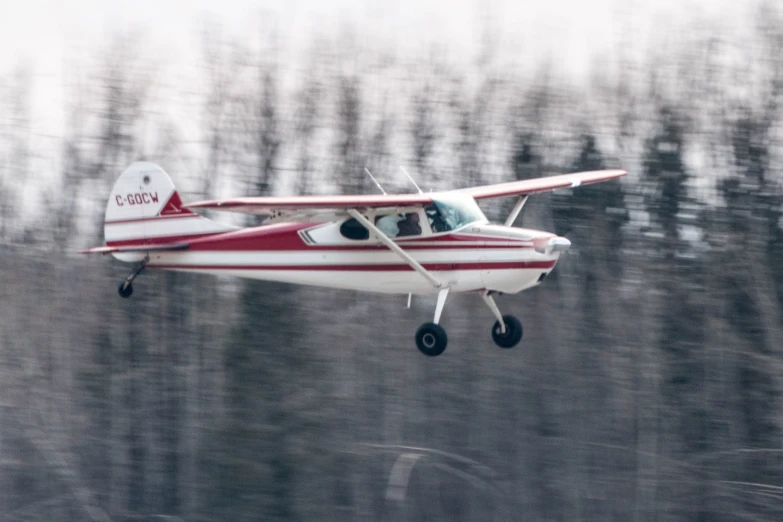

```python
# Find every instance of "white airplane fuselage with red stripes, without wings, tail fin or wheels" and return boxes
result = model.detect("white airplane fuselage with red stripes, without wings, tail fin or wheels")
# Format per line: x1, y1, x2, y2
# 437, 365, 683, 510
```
114, 218, 567, 294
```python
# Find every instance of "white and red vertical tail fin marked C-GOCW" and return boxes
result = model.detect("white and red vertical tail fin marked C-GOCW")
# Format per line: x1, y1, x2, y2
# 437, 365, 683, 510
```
103, 161, 233, 247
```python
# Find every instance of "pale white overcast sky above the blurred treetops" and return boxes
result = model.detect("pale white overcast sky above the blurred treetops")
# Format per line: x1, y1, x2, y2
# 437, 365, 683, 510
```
0, 0, 772, 173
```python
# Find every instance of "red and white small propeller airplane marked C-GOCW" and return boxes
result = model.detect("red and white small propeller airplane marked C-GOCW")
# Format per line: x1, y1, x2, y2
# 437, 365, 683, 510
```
81, 162, 626, 356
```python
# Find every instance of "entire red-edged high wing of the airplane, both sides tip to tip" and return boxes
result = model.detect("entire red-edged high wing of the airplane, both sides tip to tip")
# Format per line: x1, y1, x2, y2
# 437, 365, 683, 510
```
183, 170, 626, 214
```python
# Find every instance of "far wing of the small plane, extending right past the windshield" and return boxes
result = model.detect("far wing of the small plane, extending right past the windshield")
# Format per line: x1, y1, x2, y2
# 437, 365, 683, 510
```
454, 170, 627, 199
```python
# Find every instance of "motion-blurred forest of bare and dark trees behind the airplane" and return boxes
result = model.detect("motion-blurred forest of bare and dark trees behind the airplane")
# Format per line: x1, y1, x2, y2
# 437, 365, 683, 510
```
0, 4, 783, 521
